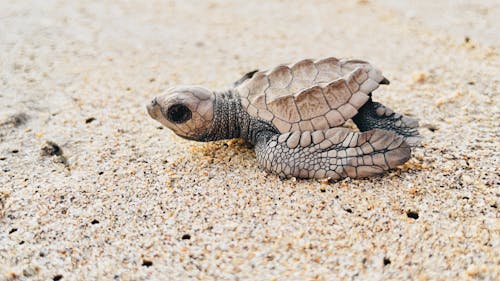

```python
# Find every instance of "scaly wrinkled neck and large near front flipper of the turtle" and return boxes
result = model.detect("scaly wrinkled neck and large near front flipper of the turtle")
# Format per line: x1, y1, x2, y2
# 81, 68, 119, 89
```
199, 91, 411, 179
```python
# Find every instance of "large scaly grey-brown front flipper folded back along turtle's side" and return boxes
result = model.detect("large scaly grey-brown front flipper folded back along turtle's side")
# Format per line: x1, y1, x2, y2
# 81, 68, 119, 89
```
256, 128, 411, 179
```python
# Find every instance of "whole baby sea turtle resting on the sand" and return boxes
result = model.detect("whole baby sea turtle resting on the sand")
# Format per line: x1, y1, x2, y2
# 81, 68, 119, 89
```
147, 57, 420, 179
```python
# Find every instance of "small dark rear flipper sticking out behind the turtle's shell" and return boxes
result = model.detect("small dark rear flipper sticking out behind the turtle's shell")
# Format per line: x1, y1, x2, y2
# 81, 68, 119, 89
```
352, 98, 422, 146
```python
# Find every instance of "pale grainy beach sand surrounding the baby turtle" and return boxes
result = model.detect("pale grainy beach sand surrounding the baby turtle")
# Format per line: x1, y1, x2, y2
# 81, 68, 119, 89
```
0, 0, 500, 280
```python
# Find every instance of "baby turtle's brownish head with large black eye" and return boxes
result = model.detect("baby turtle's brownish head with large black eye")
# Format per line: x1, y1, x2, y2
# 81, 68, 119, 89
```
147, 86, 215, 140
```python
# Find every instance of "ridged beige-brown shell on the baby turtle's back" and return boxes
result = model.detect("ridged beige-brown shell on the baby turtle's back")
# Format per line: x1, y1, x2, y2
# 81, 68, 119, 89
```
236, 57, 388, 133
